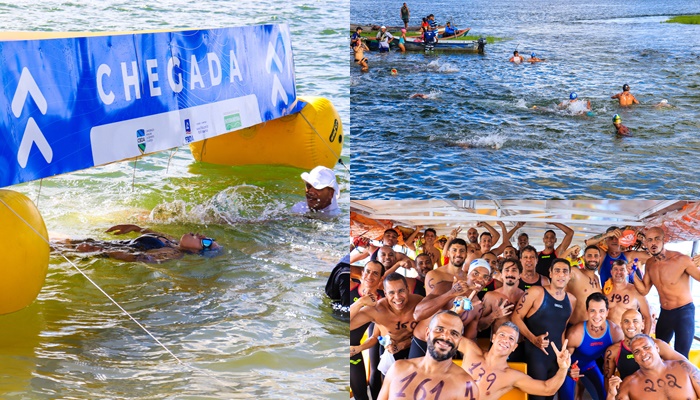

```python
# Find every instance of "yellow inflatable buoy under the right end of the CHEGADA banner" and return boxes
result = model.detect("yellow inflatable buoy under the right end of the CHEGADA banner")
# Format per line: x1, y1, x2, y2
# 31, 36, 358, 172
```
190, 97, 343, 169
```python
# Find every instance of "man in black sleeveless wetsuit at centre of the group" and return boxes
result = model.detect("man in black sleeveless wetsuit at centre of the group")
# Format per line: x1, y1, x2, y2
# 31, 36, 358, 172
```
512, 258, 576, 400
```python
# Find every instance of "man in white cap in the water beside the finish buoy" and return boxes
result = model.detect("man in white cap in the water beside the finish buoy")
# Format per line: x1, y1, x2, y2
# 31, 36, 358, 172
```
292, 166, 340, 217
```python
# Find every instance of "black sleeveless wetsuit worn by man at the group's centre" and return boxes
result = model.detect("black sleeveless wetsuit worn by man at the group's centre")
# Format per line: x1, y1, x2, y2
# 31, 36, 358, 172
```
523, 289, 572, 400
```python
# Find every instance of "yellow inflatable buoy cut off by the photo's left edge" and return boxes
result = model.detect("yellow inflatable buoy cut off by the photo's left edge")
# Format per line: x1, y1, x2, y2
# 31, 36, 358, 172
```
0, 189, 49, 314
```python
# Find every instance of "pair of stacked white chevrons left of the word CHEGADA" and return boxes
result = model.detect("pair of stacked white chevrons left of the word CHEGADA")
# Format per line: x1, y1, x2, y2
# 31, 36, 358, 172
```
12, 67, 53, 168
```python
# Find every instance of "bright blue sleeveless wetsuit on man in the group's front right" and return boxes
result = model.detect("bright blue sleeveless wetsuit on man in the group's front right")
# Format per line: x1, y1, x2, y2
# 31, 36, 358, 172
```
559, 321, 613, 400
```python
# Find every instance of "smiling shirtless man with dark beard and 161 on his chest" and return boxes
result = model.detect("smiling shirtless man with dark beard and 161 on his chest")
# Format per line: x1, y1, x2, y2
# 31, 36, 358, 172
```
379, 311, 479, 400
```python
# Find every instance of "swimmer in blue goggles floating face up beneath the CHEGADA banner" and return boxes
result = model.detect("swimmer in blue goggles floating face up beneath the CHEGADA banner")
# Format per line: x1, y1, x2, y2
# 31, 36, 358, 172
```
52, 224, 221, 263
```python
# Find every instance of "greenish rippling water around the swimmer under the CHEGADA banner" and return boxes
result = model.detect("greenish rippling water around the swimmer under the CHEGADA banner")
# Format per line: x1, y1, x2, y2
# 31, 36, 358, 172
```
0, 0, 349, 399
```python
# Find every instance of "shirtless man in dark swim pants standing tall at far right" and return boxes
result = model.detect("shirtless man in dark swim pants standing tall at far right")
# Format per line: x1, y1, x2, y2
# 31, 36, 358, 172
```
634, 227, 700, 362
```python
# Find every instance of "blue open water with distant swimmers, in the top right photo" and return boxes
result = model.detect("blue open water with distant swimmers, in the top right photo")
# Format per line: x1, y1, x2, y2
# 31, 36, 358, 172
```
350, 0, 700, 199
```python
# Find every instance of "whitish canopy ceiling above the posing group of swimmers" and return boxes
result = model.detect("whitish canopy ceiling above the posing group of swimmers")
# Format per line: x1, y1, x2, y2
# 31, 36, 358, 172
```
350, 200, 700, 248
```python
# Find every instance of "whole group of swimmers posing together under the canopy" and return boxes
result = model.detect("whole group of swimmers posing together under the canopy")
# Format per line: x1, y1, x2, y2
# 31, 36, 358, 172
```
350, 222, 700, 400
